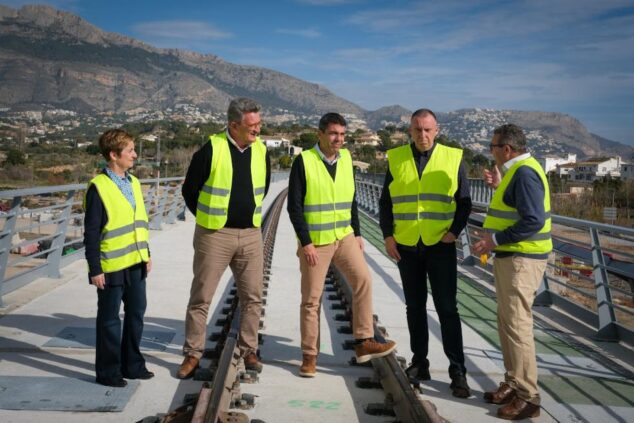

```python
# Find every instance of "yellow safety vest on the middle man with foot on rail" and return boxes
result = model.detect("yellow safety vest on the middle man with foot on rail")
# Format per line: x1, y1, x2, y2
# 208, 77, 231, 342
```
302, 148, 354, 245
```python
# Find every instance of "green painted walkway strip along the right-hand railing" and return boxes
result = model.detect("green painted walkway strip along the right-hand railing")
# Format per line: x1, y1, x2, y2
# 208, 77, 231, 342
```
359, 213, 634, 407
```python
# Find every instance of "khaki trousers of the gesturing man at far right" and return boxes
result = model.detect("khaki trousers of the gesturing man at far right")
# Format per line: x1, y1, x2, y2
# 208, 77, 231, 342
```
493, 256, 547, 405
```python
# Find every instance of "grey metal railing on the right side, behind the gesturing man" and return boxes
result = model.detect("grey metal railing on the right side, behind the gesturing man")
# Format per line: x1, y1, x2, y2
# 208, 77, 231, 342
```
356, 175, 634, 344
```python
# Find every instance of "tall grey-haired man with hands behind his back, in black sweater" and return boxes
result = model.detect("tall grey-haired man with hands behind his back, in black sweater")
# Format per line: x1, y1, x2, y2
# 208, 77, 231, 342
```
178, 98, 271, 379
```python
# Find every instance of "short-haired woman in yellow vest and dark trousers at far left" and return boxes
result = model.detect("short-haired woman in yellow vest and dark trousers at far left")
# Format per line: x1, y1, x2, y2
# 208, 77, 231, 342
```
84, 129, 154, 388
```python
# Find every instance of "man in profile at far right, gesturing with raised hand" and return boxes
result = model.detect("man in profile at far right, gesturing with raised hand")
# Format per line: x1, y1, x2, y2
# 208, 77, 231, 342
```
473, 124, 552, 420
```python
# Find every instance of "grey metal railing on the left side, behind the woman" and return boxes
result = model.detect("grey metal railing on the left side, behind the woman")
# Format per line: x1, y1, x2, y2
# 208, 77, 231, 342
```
0, 177, 185, 307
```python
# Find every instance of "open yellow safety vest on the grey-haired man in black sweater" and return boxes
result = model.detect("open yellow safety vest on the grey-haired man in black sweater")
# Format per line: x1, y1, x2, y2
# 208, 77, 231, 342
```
196, 132, 266, 229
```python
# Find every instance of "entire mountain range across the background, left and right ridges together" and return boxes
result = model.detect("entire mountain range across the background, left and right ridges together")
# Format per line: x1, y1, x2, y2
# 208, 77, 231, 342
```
0, 5, 634, 158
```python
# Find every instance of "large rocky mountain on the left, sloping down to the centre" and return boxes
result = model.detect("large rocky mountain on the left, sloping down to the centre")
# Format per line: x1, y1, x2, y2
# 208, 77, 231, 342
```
0, 6, 364, 117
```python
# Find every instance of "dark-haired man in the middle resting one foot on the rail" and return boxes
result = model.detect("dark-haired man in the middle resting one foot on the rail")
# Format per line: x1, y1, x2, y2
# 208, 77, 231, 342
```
288, 113, 396, 377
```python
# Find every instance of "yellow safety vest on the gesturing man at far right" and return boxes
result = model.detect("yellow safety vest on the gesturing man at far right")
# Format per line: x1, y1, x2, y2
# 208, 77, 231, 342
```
482, 157, 553, 254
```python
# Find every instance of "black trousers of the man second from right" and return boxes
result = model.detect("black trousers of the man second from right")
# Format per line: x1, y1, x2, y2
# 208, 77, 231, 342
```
398, 242, 467, 375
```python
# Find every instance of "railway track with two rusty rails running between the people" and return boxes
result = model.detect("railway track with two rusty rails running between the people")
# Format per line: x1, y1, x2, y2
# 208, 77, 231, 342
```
151, 190, 444, 423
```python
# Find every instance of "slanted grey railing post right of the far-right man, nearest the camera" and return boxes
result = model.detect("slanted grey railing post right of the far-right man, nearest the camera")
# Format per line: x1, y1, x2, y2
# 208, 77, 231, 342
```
590, 228, 618, 341
